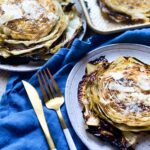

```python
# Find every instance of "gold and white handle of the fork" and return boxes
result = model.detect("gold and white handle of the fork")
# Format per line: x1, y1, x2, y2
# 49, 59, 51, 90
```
57, 109, 77, 150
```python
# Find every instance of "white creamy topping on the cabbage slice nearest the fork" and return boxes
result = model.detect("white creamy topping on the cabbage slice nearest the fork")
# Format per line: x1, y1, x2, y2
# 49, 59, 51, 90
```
105, 69, 150, 114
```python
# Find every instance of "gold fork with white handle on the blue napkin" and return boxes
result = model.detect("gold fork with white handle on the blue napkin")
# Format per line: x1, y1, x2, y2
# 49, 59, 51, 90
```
38, 69, 76, 150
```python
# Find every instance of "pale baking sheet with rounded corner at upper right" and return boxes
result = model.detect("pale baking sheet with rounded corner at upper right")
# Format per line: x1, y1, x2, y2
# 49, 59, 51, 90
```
80, 0, 150, 34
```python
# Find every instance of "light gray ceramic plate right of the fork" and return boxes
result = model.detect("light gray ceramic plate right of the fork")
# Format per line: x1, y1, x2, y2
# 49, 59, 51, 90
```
65, 44, 150, 150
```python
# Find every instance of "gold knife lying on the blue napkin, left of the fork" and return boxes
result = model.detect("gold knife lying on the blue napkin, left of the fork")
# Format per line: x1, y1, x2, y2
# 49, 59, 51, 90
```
22, 81, 56, 150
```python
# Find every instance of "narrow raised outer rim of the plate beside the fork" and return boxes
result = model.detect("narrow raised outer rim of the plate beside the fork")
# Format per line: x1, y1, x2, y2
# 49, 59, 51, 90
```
65, 43, 150, 148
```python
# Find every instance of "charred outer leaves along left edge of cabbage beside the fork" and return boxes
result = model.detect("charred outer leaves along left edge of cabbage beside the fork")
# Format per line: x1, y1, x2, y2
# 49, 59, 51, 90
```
78, 57, 140, 149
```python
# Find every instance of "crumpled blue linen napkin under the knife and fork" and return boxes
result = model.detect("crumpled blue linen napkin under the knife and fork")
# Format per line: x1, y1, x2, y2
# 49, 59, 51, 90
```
0, 28, 150, 150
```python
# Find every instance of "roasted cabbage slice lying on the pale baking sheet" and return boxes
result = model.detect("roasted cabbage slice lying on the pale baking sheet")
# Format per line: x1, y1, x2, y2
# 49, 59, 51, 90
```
99, 0, 150, 23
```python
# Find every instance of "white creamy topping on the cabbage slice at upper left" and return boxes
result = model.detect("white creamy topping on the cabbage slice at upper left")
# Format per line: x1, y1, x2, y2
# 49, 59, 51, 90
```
0, 0, 58, 25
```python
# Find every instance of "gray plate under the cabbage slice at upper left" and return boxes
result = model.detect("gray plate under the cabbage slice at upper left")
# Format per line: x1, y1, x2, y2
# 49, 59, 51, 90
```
0, 0, 87, 72
